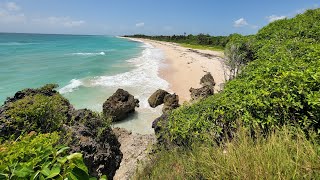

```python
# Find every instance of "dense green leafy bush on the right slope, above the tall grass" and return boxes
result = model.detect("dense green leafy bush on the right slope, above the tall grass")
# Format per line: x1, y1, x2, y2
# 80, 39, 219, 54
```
167, 9, 320, 144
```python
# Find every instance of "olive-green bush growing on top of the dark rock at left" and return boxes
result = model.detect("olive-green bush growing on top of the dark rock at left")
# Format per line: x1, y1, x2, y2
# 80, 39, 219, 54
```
0, 94, 69, 141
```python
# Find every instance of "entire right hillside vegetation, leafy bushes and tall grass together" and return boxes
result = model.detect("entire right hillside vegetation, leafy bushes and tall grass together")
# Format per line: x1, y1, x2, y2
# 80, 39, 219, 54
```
137, 9, 320, 179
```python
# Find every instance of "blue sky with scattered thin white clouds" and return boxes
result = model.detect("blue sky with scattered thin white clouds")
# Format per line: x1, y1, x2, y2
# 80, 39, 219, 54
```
0, 0, 320, 35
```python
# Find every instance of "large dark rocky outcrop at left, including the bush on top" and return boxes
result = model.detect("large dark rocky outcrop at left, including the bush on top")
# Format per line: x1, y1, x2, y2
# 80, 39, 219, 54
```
0, 85, 122, 179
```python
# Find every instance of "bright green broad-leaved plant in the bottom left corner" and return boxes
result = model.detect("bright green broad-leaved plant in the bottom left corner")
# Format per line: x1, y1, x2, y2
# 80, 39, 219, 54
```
0, 133, 89, 179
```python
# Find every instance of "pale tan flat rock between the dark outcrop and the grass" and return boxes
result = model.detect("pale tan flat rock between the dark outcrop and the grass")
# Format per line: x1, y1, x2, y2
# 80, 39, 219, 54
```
113, 128, 156, 180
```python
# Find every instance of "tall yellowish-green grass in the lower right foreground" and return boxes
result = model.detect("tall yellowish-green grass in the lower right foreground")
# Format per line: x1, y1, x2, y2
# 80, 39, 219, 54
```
135, 128, 320, 180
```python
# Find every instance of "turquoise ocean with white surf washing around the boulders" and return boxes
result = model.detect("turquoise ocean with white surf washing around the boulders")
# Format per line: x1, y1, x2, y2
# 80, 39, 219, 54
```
0, 33, 168, 134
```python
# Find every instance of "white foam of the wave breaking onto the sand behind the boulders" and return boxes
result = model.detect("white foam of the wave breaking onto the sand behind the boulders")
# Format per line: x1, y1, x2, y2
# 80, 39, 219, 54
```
90, 44, 169, 108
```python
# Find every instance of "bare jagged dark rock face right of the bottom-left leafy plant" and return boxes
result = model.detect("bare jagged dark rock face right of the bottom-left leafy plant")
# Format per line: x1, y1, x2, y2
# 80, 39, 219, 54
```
64, 123, 122, 179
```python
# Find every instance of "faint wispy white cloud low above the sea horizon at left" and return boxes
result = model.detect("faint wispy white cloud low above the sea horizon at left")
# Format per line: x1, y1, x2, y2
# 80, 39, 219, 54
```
32, 16, 86, 28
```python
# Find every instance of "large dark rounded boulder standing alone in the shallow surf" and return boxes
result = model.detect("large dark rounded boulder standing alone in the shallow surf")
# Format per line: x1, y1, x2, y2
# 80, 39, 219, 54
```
102, 89, 139, 121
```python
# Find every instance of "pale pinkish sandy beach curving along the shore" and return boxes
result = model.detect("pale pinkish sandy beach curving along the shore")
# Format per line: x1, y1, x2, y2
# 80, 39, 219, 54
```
126, 39, 225, 102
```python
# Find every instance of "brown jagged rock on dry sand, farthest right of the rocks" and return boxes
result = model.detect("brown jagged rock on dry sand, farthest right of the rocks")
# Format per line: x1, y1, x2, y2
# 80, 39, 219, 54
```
189, 73, 216, 101
